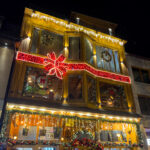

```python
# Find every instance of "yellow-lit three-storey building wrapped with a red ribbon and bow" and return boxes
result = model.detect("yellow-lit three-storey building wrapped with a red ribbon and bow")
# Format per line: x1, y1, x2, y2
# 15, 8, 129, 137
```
1, 8, 143, 150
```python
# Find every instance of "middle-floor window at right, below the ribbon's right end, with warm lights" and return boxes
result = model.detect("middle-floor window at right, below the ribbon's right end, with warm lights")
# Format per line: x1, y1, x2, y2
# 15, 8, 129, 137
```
99, 82, 128, 109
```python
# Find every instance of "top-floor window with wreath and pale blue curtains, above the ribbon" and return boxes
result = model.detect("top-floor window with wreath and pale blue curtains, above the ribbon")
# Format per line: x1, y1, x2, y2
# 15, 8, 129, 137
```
96, 46, 120, 73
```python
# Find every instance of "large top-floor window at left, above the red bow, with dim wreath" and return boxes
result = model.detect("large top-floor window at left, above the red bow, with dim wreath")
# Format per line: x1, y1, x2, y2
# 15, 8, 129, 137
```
31, 28, 63, 56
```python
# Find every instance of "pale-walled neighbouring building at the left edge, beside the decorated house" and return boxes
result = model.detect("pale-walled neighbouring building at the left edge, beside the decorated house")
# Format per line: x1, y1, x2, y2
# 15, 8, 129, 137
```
0, 16, 16, 119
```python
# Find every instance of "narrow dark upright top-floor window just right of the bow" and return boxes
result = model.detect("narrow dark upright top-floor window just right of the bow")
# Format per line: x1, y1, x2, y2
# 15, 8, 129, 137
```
69, 37, 81, 60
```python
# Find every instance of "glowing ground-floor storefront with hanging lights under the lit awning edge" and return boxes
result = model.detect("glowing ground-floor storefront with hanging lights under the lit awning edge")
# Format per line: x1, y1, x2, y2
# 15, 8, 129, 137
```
2, 105, 143, 150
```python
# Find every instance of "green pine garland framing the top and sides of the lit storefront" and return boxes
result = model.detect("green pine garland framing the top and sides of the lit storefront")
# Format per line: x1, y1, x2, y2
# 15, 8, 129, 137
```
0, 110, 144, 147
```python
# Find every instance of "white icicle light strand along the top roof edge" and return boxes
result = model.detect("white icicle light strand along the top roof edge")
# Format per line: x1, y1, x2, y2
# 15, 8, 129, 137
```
31, 13, 123, 46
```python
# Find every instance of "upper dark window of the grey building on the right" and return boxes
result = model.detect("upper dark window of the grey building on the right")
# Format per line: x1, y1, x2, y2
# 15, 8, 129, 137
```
132, 67, 150, 83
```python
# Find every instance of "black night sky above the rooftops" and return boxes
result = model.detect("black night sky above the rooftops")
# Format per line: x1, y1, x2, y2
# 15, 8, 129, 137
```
0, 0, 150, 57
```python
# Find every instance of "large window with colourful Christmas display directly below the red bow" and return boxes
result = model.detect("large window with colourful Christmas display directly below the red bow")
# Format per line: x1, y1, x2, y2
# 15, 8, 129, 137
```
23, 67, 62, 101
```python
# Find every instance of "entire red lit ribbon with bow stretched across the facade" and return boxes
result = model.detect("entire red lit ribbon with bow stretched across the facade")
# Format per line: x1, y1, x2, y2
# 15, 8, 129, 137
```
16, 51, 131, 84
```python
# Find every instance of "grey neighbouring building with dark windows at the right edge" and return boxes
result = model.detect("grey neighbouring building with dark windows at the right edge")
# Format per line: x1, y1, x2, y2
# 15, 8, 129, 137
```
126, 54, 150, 149
